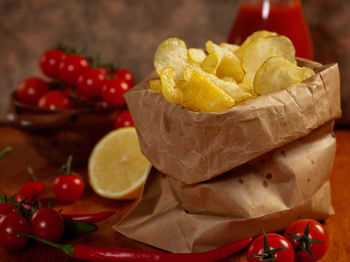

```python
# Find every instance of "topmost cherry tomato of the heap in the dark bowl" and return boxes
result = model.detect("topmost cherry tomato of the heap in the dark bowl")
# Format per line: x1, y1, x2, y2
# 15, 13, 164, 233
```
40, 49, 67, 79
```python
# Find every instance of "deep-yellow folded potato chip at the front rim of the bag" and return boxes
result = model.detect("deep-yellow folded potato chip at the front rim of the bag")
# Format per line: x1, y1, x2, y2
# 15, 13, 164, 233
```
181, 70, 235, 112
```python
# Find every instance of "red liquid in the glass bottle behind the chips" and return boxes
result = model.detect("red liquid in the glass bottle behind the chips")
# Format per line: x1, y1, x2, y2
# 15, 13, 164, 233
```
228, 0, 313, 60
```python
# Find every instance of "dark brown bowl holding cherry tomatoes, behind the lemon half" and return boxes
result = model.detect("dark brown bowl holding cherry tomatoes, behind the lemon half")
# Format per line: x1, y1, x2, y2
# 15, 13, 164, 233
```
6, 94, 120, 166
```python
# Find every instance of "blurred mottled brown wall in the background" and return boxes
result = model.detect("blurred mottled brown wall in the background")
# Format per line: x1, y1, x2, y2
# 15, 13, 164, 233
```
0, 0, 350, 125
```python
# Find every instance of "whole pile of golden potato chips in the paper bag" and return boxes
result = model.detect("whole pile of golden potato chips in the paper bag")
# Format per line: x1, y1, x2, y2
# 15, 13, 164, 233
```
150, 31, 314, 112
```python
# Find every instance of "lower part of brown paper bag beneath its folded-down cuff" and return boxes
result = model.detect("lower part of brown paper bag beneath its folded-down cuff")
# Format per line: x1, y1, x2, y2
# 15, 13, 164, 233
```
114, 120, 335, 252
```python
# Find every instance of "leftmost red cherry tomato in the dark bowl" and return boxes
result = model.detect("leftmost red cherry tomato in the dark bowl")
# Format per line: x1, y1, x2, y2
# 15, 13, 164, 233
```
16, 77, 50, 106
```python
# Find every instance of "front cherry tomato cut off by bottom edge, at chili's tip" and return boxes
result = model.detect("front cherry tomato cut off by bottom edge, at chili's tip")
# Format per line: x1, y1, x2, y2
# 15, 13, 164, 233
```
247, 233, 294, 262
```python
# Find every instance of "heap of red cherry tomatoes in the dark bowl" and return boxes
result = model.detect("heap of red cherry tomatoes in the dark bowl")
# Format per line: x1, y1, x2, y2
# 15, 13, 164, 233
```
16, 46, 135, 127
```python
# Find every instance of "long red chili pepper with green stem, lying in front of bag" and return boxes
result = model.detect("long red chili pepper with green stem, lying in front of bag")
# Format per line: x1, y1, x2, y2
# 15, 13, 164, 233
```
20, 234, 252, 262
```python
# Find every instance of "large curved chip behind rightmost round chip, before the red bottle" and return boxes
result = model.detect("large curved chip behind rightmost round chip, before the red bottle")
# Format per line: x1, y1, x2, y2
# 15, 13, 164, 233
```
242, 36, 296, 73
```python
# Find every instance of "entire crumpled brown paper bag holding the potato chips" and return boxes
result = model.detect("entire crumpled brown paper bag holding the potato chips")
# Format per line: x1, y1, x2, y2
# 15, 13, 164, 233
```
114, 61, 341, 252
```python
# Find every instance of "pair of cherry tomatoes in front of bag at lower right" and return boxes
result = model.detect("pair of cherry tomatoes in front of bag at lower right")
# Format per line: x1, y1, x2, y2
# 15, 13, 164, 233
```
247, 219, 329, 262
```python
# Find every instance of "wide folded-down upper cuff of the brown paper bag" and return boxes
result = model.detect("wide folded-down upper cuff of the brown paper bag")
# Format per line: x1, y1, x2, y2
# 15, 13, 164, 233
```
125, 60, 341, 184
